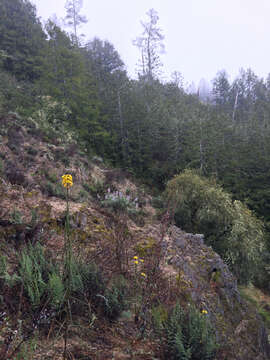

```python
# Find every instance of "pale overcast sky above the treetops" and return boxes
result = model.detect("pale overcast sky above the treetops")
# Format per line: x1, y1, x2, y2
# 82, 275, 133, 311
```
31, 0, 270, 84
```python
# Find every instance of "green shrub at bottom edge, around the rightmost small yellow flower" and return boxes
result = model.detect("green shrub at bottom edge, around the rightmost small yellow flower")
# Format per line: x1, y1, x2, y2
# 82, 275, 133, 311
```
164, 304, 217, 360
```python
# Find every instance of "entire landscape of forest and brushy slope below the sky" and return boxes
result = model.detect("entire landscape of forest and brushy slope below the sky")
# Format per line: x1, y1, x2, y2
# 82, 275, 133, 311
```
0, 0, 270, 360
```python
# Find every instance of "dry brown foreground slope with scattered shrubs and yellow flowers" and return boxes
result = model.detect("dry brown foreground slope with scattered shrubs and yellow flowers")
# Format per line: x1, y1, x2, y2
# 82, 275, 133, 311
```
0, 113, 270, 360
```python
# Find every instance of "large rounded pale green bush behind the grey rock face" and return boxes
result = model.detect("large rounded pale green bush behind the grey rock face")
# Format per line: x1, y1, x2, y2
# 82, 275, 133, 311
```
166, 170, 264, 283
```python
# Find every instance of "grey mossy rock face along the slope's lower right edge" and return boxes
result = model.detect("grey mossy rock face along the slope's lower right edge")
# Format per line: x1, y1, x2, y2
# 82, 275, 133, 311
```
167, 226, 270, 360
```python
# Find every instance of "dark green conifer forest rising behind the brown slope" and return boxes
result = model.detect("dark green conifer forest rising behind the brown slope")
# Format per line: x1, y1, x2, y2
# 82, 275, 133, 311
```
0, 0, 270, 284
